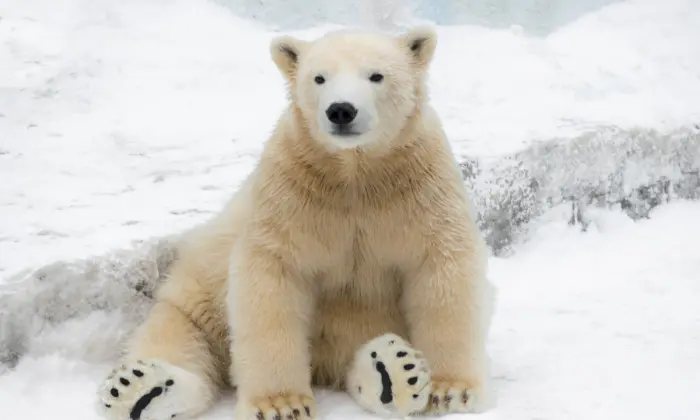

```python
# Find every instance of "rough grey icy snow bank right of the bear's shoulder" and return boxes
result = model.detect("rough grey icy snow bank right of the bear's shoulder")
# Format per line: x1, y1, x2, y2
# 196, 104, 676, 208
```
462, 126, 700, 253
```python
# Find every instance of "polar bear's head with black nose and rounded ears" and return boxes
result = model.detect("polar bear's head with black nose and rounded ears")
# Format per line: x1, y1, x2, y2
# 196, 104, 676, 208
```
271, 27, 437, 149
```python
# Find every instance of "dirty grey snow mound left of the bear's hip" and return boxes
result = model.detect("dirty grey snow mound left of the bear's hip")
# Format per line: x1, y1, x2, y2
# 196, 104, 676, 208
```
0, 237, 177, 371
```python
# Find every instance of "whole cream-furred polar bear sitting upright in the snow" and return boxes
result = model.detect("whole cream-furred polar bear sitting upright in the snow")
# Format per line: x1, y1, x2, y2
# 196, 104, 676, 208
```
99, 27, 489, 420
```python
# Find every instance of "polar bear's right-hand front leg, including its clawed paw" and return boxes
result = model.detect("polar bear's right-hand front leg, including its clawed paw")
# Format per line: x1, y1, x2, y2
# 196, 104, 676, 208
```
401, 246, 490, 414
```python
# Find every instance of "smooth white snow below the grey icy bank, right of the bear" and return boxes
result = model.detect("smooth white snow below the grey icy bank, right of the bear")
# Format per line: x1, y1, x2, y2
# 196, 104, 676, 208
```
491, 202, 700, 420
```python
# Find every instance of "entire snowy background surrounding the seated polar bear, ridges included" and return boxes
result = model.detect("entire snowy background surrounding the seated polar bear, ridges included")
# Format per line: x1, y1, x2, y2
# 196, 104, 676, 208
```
0, 0, 700, 420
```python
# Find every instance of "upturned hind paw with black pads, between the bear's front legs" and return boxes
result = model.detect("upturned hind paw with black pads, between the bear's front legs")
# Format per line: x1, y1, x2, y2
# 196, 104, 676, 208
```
347, 334, 431, 417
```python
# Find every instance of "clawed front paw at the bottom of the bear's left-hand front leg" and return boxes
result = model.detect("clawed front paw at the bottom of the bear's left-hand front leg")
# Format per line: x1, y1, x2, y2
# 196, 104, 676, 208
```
236, 394, 316, 420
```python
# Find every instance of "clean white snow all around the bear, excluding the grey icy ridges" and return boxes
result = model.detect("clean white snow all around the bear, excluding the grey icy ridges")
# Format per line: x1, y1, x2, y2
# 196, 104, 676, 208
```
0, 0, 700, 420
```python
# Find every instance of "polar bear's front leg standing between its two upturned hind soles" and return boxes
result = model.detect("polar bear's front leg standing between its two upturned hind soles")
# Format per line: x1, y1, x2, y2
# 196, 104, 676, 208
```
228, 244, 316, 420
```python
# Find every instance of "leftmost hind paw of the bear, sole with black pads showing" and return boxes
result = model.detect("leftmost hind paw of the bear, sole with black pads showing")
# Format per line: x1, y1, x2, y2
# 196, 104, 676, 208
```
98, 360, 210, 420
